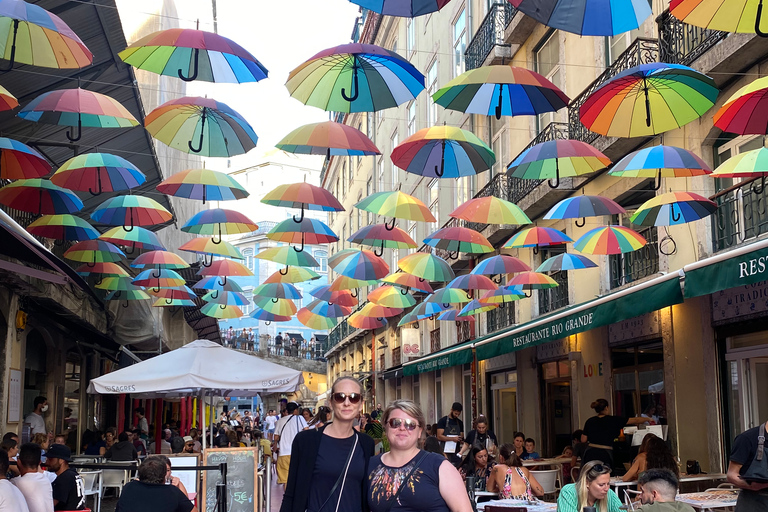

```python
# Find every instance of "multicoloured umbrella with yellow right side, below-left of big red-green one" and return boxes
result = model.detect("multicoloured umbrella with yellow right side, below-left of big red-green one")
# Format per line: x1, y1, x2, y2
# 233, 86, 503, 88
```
507, 139, 611, 188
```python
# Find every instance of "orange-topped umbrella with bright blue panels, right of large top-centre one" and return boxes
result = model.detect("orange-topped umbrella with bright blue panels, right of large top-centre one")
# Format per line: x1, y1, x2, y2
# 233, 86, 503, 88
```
432, 65, 570, 119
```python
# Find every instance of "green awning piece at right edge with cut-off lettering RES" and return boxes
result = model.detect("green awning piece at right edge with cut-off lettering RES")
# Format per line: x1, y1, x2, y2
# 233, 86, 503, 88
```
683, 240, 768, 299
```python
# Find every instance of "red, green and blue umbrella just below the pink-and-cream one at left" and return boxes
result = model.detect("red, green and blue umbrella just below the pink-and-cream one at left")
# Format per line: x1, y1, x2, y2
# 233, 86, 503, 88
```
51, 153, 147, 195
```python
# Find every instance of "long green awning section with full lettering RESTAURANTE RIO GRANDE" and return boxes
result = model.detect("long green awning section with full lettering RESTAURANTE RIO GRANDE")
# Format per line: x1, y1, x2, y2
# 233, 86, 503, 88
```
474, 272, 683, 362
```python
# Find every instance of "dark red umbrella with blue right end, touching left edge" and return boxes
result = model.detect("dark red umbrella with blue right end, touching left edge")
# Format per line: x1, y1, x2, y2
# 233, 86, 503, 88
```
0, 178, 83, 215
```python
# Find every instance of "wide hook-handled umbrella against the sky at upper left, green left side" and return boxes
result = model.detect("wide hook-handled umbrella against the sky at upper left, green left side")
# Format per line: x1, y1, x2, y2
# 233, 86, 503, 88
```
119, 28, 268, 84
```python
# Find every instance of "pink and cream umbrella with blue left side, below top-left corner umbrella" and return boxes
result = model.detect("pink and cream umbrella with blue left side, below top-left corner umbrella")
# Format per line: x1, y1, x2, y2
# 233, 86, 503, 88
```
18, 87, 139, 142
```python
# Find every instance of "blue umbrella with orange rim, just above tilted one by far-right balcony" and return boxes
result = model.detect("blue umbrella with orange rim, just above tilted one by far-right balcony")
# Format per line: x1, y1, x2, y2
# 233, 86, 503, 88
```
608, 146, 712, 190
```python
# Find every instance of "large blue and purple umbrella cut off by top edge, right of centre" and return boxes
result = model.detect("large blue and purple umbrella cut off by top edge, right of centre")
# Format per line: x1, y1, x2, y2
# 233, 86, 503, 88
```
510, 0, 652, 37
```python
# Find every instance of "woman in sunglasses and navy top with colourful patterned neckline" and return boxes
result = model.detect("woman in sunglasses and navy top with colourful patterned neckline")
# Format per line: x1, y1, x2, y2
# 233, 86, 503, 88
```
368, 400, 472, 512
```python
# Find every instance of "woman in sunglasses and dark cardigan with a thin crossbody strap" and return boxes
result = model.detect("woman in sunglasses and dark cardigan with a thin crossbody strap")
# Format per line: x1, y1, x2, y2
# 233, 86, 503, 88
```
280, 377, 374, 512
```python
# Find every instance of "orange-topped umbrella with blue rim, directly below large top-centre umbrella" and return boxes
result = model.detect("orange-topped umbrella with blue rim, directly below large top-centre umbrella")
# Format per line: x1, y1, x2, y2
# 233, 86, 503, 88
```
275, 121, 381, 158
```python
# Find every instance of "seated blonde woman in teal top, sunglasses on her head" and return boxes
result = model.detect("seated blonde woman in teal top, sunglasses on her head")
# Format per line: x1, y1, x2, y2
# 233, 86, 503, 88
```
557, 460, 621, 512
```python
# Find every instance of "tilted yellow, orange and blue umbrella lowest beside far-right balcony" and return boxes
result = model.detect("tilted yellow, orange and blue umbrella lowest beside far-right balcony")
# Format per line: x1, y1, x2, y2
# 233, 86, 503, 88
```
629, 192, 717, 226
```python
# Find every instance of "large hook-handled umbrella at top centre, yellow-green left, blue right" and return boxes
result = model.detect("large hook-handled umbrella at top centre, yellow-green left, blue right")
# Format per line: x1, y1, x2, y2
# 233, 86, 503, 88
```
285, 43, 424, 113
